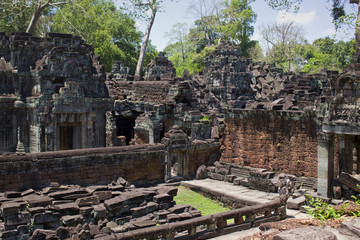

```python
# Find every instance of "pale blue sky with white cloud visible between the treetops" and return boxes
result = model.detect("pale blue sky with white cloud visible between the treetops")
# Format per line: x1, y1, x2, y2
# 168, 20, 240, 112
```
139, 0, 355, 51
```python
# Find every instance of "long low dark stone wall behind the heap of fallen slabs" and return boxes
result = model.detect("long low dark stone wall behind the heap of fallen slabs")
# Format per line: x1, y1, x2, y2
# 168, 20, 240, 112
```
0, 144, 165, 191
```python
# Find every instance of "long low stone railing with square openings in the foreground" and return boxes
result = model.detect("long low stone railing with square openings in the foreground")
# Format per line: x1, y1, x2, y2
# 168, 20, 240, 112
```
112, 199, 286, 240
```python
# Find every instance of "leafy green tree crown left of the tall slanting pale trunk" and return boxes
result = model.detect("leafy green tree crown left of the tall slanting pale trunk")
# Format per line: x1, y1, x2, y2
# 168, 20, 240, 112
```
51, 0, 141, 73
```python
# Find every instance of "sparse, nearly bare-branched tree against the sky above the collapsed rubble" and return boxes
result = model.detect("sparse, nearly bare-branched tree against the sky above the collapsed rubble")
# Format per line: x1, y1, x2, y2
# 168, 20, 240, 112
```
261, 22, 304, 71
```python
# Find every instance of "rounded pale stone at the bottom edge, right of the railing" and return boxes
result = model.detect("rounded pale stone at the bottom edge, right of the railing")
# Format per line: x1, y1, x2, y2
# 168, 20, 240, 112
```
274, 227, 337, 240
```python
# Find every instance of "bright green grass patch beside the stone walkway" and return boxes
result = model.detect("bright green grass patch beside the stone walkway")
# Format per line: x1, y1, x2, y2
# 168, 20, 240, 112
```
174, 186, 230, 216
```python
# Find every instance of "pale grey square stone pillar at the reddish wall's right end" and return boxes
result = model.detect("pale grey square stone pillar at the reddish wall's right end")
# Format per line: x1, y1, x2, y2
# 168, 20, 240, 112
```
317, 133, 334, 197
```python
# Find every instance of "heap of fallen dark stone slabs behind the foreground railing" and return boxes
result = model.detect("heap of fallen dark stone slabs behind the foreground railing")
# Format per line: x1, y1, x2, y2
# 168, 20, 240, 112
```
0, 178, 201, 240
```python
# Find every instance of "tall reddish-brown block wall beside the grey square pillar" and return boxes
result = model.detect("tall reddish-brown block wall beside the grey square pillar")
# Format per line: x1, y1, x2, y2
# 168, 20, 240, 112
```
221, 110, 317, 177
